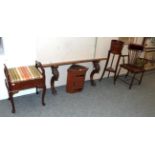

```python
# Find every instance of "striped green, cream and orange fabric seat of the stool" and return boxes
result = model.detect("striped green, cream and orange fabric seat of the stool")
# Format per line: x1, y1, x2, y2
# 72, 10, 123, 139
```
8, 66, 43, 83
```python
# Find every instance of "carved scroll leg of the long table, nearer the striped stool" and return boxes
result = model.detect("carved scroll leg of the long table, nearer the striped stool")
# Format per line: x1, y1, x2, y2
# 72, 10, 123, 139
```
51, 66, 59, 95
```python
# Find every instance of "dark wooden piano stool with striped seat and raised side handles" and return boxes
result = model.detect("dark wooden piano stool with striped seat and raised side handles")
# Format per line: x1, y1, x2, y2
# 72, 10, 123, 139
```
4, 61, 46, 113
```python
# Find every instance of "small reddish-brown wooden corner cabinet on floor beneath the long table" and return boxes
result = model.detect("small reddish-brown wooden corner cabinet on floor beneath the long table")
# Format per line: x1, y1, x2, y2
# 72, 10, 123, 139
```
66, 65, 88, 93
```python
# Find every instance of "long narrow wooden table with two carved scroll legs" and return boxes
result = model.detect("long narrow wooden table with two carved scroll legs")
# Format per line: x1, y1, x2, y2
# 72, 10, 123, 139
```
43, 58, 107, 95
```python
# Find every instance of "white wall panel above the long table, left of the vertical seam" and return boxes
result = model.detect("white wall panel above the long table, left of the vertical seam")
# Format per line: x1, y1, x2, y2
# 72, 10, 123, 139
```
36, 37, 95, 64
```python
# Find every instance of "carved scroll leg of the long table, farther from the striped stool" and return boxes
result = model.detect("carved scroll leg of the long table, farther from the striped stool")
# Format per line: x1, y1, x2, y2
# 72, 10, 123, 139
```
90, 61, 100, 86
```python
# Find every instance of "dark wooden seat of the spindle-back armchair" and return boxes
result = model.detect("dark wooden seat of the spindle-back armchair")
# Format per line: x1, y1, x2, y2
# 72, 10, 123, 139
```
120, 64, 145, 73
